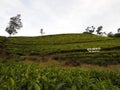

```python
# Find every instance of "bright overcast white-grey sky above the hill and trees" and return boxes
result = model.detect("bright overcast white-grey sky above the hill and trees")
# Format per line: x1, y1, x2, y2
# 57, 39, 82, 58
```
0, 0, 120, 36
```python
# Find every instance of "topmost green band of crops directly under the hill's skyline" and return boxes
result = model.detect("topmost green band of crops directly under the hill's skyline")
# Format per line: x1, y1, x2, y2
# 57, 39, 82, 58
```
7, 34, 112, 45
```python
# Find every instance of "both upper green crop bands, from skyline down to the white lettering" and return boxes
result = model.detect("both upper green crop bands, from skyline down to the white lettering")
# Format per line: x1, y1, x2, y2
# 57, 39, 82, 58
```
7, 34, 120, 55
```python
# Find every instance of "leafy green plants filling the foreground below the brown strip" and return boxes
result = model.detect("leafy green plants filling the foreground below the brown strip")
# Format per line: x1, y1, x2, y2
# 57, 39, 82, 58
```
0, 62, 120, 90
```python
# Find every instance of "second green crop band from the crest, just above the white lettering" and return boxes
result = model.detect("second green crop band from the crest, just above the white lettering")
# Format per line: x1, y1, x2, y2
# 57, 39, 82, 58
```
7, 41, 120, 55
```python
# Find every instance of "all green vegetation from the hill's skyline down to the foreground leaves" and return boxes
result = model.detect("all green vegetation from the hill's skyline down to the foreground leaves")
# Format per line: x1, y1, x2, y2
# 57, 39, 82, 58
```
0, 34, 120, 90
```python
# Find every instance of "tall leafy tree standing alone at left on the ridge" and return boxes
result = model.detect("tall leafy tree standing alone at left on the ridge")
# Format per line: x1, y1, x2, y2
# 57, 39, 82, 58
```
5, 14, 23, 36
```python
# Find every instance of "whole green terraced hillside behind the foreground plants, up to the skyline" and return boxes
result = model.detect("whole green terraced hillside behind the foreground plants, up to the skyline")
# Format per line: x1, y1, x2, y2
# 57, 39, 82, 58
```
0, 34, 120, 65
